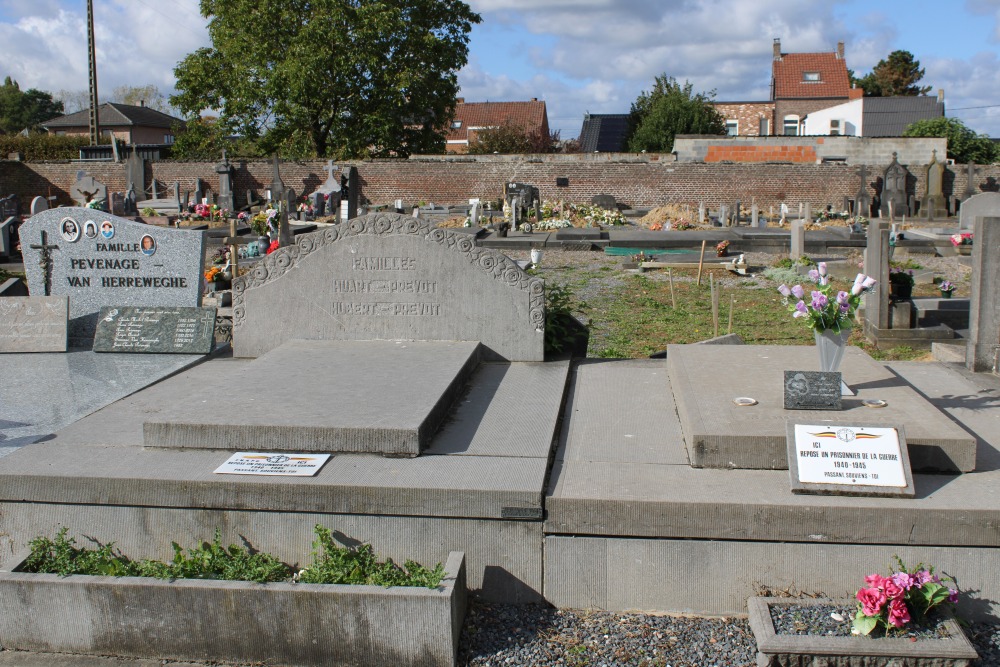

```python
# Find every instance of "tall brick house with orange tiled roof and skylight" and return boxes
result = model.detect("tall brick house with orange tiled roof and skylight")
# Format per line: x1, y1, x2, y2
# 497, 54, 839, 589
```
715, 39, 864, 137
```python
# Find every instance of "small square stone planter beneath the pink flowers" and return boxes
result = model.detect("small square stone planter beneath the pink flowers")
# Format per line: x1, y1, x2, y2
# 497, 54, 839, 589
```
747, 597, 979, 667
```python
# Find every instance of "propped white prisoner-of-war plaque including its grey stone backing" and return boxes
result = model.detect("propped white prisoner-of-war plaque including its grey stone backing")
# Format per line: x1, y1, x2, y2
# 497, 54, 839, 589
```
788, 422, 914, 498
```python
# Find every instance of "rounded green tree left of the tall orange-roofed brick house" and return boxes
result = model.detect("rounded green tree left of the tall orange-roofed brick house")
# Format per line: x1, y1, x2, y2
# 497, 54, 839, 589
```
626, 74, 726, 153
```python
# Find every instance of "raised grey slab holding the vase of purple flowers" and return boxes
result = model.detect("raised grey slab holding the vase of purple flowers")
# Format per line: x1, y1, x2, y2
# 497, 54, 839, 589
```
667, 345, 976, 472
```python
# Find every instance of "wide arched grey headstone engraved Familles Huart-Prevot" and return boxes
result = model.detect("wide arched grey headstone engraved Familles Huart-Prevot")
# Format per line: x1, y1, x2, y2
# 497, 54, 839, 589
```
233, 213, 545, 361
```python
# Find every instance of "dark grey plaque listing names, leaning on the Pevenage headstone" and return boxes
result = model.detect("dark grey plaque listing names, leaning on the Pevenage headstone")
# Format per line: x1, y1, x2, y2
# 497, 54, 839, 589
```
94, 306, 215, 354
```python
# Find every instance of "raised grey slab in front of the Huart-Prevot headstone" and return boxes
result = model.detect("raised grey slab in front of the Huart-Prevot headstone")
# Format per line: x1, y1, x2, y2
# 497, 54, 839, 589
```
143, 340, 480, 456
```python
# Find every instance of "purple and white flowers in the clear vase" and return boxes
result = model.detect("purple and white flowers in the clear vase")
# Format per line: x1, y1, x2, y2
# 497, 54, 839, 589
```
778, 262, 876, 334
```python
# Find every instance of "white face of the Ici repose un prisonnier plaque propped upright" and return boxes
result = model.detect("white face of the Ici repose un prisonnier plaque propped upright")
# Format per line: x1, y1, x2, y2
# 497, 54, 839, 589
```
795, 424, 906, 488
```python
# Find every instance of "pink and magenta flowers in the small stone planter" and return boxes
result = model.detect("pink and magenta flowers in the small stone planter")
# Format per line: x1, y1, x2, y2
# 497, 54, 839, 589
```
851, 558, 958, 635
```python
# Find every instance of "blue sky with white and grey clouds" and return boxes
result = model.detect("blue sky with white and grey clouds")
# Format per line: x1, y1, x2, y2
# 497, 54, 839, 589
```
0, 0, 1000, 139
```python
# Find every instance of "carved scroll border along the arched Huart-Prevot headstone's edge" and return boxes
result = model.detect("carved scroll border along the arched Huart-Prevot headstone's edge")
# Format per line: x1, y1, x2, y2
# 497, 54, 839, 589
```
233, 213, 545, 361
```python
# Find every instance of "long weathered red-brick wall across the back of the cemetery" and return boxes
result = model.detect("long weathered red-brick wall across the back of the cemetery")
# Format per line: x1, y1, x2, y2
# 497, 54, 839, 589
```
0, 155, 1000, 212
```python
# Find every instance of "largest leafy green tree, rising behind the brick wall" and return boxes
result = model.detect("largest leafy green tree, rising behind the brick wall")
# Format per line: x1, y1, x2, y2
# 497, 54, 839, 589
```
170, 0, 480, 157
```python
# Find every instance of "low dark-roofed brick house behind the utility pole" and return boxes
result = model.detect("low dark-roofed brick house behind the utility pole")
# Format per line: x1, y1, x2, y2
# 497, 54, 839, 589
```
41, 102, 184, 144
